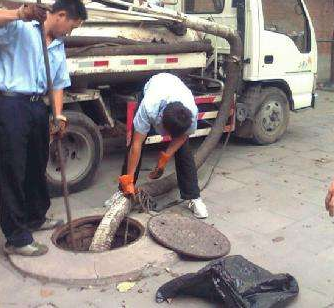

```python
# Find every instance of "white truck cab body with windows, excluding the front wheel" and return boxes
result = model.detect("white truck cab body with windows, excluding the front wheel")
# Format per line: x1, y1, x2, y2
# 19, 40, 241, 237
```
169, 0, 317, 110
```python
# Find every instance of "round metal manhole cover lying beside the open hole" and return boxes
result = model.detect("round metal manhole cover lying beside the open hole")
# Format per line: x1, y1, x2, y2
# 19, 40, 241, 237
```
148, 214, 231, 260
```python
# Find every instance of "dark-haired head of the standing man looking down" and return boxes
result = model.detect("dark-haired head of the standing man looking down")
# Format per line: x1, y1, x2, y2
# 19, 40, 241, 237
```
46, 0, 87, 38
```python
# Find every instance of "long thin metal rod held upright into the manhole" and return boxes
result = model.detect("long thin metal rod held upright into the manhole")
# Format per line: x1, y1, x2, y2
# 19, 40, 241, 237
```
37, 0, 76, 250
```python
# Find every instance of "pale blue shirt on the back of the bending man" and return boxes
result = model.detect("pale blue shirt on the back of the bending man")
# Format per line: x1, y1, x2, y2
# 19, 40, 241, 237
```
133, 73, 198, 135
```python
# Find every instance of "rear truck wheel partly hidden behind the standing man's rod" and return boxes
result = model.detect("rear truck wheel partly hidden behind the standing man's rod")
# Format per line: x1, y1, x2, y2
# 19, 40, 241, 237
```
46, 111, 103, 196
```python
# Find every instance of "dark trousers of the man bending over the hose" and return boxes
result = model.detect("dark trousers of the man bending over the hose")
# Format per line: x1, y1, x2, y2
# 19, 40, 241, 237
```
122, 139, 200, 200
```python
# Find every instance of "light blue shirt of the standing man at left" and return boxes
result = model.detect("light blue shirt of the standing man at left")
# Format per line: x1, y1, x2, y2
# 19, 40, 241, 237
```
0, 20, 71, 94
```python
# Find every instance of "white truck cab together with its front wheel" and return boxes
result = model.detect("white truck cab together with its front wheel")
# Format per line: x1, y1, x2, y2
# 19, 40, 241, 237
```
167, 0, 317, 144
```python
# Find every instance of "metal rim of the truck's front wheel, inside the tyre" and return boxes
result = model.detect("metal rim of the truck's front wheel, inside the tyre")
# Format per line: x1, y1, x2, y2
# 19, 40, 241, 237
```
261, 100, 284, 134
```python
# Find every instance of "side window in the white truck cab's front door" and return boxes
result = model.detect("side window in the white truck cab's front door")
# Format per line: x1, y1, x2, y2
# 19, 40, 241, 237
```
262, 0, 311, 53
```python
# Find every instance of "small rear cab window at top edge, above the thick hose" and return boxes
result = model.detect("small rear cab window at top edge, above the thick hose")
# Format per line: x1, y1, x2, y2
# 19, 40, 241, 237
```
185, 0, 225, 14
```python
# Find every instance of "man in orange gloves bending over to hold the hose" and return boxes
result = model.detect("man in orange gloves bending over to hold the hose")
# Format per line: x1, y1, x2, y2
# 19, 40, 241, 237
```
116, 73, 208, 218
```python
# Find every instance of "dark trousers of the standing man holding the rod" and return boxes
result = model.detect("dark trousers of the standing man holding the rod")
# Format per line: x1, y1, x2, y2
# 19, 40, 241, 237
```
0, 96, 50, 247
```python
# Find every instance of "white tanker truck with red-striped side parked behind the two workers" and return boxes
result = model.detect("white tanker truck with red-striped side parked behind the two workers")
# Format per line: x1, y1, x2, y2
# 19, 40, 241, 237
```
4, 0, 317, 192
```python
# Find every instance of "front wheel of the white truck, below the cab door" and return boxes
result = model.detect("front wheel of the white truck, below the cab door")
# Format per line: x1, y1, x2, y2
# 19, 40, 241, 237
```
252, 88, 290, 145
